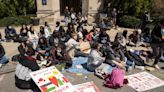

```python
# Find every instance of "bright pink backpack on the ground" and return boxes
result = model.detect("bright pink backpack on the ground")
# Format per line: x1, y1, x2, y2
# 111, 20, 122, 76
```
104, 68, 125, 89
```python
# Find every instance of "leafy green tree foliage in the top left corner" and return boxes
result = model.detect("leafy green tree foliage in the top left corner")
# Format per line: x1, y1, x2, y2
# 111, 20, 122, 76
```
0, 0, 36, 18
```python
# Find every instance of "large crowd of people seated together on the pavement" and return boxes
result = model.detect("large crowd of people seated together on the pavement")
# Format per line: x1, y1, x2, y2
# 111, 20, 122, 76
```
2, 17, 160, 88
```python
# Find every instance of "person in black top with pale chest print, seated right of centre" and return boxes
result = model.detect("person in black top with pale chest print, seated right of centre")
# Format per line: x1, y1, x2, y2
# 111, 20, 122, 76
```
99, 29, 111, 44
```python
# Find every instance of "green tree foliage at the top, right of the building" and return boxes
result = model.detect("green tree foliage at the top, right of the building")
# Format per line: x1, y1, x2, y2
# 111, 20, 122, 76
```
104, 0, 154, 16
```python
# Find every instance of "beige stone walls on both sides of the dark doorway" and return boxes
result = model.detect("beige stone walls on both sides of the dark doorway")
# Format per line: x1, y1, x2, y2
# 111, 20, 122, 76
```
36, 0, 103, 22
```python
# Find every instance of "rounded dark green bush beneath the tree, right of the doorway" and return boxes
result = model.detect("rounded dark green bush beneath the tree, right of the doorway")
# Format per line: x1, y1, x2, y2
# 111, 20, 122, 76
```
118, 15, 142, 28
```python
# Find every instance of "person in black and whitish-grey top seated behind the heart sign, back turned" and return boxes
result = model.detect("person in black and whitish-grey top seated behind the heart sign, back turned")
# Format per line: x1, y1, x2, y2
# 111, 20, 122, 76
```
15, 49, 40, 92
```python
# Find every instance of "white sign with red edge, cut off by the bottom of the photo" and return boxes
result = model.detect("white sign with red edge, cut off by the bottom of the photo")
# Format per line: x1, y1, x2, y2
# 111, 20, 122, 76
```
74, 82, 101, 92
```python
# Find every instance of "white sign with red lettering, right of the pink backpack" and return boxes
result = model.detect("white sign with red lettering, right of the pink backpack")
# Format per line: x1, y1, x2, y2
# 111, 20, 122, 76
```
127, 72, 164, 92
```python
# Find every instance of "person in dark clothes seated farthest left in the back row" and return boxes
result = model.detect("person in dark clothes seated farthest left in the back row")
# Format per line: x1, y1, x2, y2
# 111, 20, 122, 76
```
5, 26, 17, 41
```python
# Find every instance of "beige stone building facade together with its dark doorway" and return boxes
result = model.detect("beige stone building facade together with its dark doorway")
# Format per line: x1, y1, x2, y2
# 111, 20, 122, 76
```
36, 0, 103, 22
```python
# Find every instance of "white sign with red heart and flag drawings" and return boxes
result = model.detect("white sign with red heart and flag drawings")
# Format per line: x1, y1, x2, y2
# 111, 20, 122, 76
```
30, 66, 76, 92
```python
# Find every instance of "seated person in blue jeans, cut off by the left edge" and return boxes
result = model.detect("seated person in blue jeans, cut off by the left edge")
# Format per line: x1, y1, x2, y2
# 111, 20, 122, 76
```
0, 43, 9, 67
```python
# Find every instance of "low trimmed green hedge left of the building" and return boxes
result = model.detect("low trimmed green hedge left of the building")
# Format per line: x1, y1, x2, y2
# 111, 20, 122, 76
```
0, 15, 37, 27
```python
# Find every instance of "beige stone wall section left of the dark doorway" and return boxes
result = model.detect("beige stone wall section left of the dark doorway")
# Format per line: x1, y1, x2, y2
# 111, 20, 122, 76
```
36, 0, 60, 24
